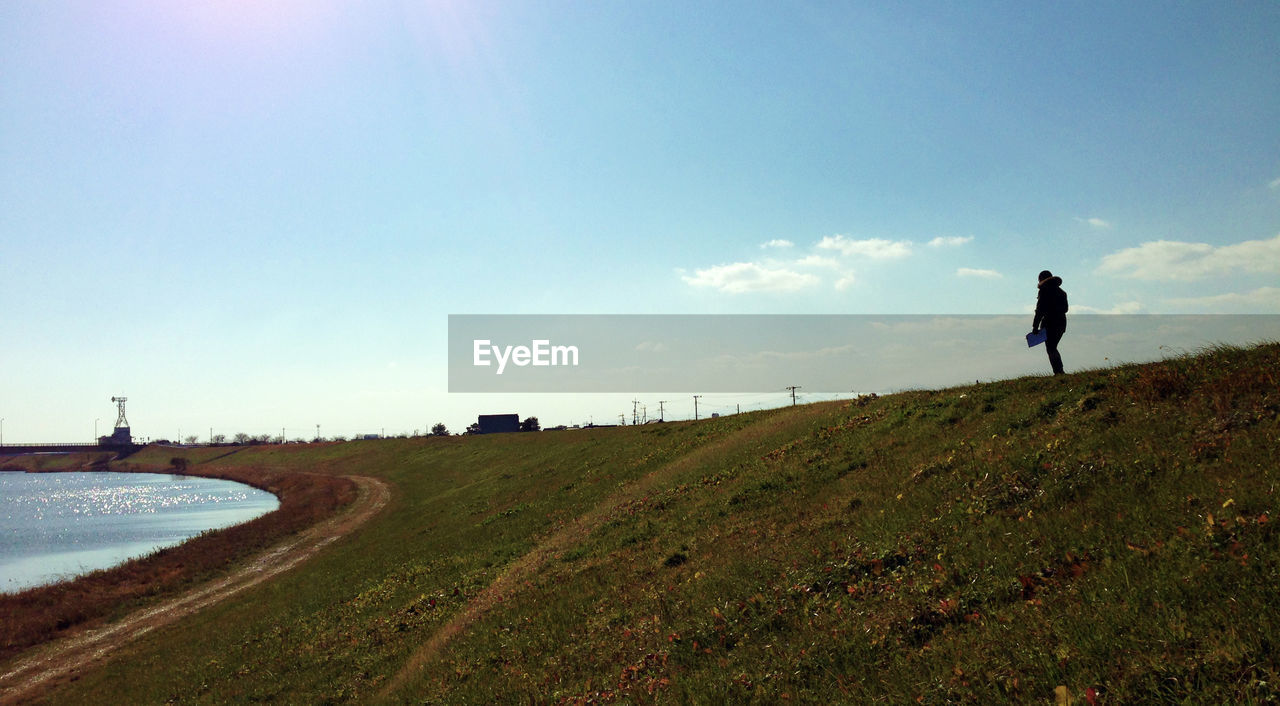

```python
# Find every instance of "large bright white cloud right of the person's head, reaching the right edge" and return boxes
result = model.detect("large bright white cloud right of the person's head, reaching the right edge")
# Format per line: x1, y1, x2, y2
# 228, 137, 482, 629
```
1097, 235, 1280, 280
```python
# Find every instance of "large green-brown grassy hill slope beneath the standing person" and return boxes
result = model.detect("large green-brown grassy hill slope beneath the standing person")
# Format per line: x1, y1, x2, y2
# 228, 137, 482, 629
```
12, 344, 1280, 703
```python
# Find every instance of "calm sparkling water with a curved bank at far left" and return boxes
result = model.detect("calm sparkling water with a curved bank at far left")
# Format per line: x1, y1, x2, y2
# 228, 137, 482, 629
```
0, 472, 280, 592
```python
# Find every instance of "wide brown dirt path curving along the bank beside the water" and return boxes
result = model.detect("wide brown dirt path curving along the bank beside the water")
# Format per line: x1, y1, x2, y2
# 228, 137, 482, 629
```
0, 476, 390, 705
